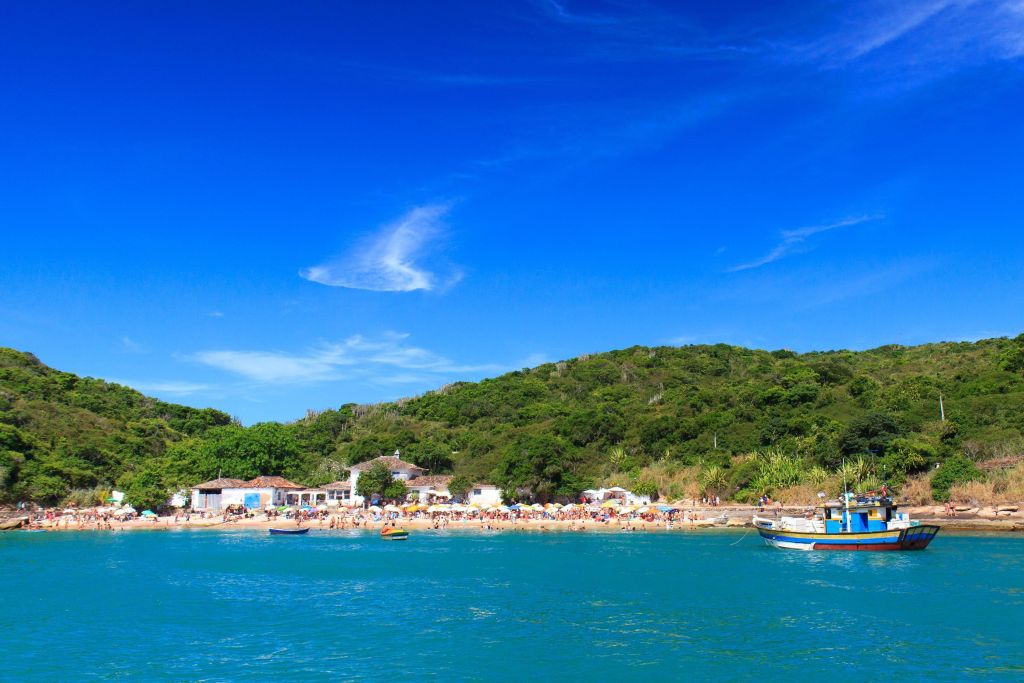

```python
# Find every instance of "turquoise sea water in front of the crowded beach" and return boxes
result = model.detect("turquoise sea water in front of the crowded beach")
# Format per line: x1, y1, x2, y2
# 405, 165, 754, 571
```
0, 530, 1024, 681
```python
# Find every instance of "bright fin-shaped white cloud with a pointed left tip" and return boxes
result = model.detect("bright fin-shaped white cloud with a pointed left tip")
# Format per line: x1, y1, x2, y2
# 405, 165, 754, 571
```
299, 204, 462, 292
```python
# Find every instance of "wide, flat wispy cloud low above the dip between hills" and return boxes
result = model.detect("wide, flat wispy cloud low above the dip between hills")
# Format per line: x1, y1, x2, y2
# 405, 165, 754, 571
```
187, 334, 502, 384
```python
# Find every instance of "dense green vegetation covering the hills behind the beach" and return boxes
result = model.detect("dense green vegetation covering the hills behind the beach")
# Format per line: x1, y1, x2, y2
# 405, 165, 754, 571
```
0, 335, 1024, 505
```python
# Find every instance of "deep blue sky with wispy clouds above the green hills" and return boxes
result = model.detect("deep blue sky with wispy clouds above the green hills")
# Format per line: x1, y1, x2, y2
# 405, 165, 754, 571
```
0, 0, 1024, 423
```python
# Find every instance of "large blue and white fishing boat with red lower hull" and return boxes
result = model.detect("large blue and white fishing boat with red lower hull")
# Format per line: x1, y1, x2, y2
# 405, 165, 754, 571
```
754, 494, 940, 550
